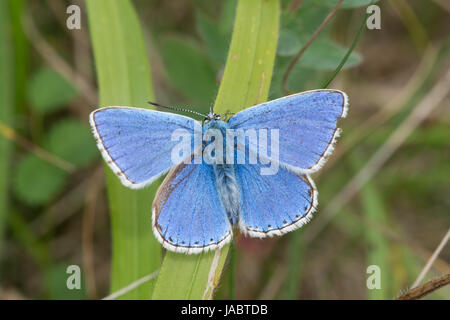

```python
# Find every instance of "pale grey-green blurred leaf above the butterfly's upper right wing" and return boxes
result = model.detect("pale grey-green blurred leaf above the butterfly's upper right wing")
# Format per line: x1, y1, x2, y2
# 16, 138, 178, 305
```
297, 39, 362, 71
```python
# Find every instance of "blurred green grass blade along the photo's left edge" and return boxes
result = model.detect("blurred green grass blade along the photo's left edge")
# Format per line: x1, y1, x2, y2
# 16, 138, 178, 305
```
0, 1, 14, 264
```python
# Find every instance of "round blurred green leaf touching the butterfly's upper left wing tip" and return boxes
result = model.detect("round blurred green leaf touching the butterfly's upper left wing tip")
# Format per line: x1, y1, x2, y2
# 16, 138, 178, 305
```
46, 119, 99, 166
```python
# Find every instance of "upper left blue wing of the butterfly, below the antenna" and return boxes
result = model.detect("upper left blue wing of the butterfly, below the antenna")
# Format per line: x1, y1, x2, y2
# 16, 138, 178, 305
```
90, 107, 201, 189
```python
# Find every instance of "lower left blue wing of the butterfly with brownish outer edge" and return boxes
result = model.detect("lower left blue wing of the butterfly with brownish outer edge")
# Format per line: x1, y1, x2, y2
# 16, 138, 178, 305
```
152, 156, 232, 253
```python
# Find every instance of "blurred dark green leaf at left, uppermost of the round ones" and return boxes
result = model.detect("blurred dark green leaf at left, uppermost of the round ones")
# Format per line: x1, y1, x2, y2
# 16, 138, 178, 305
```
28, 68, 77, 113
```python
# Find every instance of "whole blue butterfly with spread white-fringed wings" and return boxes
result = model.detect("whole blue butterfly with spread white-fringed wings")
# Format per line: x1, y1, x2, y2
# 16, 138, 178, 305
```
90, 90, 348, 253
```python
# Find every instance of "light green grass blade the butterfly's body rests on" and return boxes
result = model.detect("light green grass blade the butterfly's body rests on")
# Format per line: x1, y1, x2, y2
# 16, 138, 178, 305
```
153, 0, 280, 299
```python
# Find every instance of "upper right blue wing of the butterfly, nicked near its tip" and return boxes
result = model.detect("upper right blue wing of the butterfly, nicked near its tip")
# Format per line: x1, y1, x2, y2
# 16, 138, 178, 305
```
228, 90, 348, 174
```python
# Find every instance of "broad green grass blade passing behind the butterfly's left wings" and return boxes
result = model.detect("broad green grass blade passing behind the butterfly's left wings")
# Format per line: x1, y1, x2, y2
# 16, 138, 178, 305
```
86, 0, 161, 299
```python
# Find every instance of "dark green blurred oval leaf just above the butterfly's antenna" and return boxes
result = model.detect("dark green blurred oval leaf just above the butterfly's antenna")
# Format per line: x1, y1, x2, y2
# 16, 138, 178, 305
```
162, 37, 217, 104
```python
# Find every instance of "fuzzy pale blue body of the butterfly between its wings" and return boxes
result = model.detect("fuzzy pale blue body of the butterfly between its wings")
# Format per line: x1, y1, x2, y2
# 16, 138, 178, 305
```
203, 120, 241, 225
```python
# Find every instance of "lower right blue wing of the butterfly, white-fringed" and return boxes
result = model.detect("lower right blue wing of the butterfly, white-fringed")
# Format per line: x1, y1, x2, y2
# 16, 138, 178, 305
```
236, 164, 317, 238
